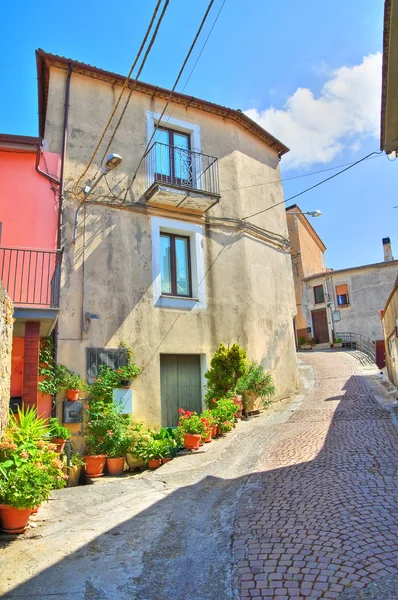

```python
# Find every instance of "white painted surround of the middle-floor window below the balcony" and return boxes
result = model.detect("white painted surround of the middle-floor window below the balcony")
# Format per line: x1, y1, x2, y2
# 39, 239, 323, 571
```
151, 217, 206, 310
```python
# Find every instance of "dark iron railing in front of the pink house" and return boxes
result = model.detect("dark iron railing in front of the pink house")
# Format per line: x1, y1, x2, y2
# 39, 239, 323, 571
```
0, 247, 62, 308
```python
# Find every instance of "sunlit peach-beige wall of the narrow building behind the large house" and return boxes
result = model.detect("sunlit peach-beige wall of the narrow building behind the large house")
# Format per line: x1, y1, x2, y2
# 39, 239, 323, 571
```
286, 209, 325, 336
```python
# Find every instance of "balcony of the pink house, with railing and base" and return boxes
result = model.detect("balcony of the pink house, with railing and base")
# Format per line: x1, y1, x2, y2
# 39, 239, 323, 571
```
0, 247, 62, 337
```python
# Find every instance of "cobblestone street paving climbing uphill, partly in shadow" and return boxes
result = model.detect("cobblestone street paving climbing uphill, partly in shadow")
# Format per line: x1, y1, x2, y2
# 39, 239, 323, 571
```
234, 352, 398, 600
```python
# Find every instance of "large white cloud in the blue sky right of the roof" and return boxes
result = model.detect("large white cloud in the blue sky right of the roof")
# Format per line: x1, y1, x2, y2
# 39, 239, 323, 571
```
245, 52, 382, 168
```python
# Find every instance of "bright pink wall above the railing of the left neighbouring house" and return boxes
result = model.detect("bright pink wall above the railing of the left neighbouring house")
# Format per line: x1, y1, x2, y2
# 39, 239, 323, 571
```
0, 150, 60, 250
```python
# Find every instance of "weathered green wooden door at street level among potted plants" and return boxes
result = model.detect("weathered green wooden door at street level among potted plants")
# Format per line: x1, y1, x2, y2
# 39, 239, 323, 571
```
160, 354, 202, 427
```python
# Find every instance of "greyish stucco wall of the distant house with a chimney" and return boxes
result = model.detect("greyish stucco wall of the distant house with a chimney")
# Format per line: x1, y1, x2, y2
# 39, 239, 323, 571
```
306, 261, 398, 340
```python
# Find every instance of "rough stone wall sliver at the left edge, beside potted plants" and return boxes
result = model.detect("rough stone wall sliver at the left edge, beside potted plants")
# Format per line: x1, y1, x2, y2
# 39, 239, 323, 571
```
0, 280, 14, 433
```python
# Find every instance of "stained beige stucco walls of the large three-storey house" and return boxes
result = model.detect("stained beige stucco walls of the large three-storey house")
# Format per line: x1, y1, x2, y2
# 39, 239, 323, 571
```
45, 69, 296, 423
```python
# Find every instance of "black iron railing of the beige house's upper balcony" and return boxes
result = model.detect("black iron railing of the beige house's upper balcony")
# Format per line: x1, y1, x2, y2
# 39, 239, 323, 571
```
147, 142, 220, 196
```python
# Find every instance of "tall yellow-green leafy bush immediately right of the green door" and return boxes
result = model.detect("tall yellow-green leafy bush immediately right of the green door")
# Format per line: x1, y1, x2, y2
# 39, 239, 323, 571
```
205, 344, 247, 408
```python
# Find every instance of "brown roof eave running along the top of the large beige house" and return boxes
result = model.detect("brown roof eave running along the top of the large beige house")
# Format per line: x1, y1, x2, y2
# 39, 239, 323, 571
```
36, 48, 289, 156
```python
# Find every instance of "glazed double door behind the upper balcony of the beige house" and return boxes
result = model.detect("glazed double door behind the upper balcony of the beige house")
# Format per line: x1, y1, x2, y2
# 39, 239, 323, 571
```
155, 127, 193, 187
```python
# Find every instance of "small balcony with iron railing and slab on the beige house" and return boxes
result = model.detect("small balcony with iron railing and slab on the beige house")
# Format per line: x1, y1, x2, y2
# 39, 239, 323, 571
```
145, 142, 220, 213
